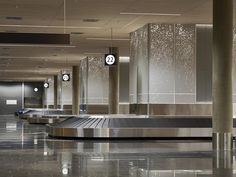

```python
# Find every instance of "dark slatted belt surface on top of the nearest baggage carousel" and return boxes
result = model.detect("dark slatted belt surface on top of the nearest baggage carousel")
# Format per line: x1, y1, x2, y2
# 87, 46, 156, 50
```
53, 117, 212, 128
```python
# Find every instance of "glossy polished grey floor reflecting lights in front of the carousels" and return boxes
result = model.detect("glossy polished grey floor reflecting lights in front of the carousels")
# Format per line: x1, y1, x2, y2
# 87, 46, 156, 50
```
0, 116, 236, 177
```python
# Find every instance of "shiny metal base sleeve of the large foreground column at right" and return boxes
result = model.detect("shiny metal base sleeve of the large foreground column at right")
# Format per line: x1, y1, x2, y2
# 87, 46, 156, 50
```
212, 132, 233, 151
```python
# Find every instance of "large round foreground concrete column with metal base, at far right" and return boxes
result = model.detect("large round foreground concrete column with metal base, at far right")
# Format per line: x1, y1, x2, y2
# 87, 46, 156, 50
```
212, 0, 233, 150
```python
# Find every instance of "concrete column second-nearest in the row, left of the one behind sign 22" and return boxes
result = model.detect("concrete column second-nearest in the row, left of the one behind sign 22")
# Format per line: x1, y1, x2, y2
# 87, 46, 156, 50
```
72, 66, 80, 115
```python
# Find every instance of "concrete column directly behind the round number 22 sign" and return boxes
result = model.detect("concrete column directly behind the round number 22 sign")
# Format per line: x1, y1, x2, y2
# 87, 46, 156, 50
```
109, 47, 120, 114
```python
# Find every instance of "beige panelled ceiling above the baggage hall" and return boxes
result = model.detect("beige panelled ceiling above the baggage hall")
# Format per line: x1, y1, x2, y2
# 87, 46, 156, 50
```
0, 0, 230, 80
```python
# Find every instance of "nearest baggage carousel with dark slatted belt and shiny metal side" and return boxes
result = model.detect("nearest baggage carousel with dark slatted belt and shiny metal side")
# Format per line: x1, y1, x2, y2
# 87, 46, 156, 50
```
47, 116, 236, 138
